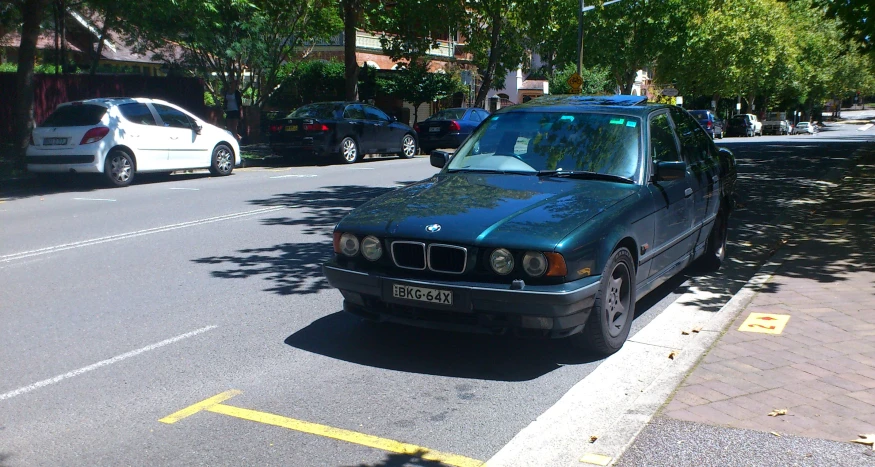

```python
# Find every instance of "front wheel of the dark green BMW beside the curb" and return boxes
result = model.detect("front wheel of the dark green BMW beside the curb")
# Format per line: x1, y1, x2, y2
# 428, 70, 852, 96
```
572, 248, 636, 356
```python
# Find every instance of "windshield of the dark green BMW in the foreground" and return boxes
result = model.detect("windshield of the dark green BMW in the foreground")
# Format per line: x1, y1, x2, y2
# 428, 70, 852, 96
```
447, 112, 641, 179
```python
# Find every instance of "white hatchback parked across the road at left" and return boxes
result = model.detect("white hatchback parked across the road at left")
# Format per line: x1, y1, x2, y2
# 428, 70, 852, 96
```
27, 98, 242, 186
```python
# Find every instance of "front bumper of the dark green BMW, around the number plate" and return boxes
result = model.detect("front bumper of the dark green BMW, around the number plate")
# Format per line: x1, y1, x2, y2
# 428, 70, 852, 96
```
322, 261, 599, 338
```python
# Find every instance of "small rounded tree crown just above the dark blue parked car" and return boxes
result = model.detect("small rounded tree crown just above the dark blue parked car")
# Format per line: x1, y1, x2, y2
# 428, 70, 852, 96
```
377, 62, 465, 123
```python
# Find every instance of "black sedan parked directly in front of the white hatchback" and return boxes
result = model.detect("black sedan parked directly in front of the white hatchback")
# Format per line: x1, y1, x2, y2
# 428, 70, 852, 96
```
269, 102, 417, 164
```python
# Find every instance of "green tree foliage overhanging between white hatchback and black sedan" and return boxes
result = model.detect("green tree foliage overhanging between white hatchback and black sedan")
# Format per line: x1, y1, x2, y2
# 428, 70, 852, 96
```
123, 0, 341, 105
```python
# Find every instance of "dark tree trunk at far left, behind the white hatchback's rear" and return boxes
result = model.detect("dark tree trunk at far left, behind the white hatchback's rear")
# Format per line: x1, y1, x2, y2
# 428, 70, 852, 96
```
12, 0, 48, 167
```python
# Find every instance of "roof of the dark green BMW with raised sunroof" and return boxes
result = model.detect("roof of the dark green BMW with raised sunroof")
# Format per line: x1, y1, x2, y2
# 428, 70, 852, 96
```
496, 94, 671, 116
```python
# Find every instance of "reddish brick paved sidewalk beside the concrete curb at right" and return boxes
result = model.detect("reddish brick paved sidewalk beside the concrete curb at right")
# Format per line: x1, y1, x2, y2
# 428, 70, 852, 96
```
662, 155, 875, 441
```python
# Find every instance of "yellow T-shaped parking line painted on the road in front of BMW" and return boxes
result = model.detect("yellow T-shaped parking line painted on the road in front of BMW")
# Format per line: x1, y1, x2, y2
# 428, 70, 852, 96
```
159, 390, 483, 467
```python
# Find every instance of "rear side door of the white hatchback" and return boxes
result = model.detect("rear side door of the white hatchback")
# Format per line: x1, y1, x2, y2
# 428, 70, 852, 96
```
118, 102, 170, 170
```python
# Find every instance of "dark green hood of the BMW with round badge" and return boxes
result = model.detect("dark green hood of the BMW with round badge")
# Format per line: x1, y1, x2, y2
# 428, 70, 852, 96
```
338, 173, 639, 250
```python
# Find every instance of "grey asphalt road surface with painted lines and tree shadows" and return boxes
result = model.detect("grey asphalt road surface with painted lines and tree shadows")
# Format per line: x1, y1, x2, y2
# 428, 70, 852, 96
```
0, 126, 872, 466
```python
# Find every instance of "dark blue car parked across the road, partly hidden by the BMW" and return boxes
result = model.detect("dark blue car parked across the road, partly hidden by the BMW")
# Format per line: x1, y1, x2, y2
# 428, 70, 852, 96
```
413, 108, 489, 153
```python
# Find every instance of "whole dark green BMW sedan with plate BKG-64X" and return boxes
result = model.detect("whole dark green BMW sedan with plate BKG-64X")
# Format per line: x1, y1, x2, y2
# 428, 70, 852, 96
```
323, 96, 736, 355
